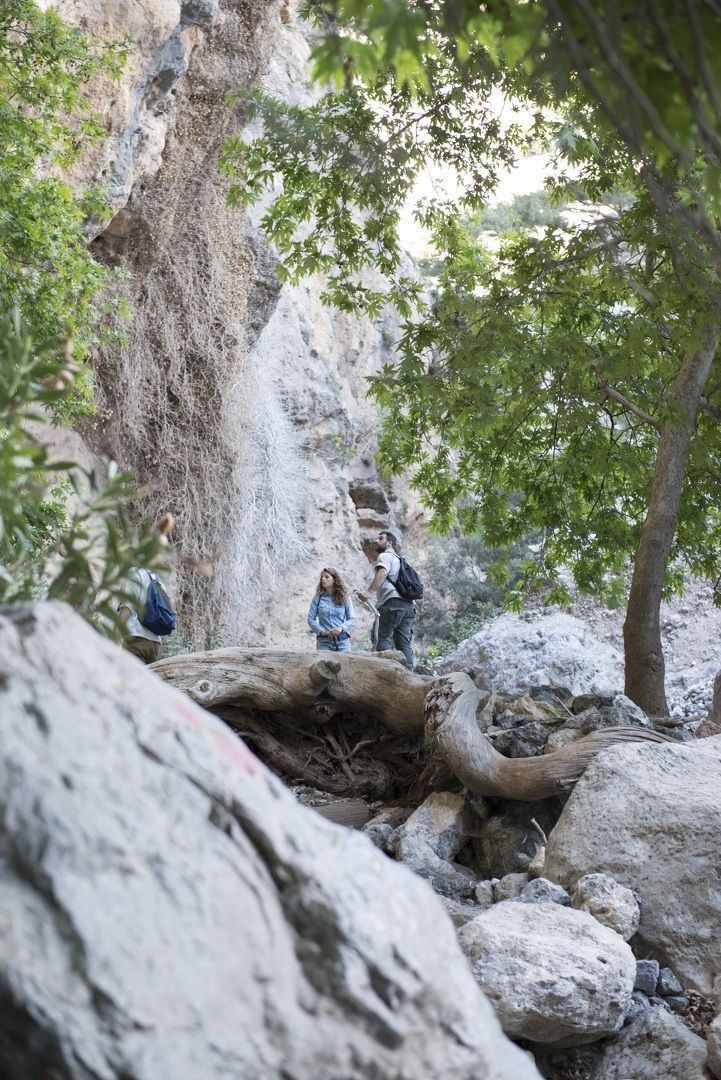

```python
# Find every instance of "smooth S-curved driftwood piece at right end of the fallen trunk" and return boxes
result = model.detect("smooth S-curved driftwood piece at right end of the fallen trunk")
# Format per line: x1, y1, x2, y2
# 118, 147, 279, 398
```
425, 672, 671, 802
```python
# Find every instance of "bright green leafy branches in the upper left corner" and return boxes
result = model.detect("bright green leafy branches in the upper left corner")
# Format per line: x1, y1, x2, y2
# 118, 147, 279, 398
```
0, 0, 125, 395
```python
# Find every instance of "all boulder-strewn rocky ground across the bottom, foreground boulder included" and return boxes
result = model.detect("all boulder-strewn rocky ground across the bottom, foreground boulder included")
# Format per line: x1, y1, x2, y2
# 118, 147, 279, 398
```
0, 604, 721, 1080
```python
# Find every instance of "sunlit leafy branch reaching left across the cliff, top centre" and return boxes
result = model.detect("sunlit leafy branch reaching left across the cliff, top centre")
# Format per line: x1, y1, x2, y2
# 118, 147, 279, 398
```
221, 52, 520, 315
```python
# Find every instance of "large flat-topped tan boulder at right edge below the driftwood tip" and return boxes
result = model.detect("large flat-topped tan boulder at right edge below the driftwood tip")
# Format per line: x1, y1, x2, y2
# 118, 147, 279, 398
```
544, 737, 721, 994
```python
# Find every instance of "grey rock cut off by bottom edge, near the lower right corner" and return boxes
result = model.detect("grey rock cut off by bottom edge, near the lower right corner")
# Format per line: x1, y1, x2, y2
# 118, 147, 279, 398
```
593, 1009, 708, 1080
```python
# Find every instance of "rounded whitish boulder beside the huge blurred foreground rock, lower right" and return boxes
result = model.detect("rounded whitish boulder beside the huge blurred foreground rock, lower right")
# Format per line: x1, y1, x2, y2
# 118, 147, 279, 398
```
459, 901, 636, 1047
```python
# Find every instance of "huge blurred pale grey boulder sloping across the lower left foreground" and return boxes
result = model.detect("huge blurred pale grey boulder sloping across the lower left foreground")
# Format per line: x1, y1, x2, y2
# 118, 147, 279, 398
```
0, 604, 538, 1080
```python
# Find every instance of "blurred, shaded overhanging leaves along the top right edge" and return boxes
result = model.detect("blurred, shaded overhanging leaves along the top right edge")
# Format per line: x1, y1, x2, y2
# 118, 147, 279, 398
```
304, 0, 721, 256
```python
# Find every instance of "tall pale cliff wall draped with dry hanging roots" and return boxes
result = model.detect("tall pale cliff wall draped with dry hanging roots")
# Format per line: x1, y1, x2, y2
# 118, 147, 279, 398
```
53, 0, 418, 646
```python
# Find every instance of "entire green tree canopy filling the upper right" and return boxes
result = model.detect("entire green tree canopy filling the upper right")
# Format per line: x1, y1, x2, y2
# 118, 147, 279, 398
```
225, 0, 721, 600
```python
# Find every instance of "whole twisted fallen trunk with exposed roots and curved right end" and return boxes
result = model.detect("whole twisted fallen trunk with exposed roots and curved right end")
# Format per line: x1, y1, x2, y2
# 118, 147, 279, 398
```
152, 649, 668, 801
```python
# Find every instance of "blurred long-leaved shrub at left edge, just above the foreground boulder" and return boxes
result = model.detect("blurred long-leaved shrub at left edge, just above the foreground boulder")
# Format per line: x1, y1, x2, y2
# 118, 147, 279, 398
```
0, 312, 169, 635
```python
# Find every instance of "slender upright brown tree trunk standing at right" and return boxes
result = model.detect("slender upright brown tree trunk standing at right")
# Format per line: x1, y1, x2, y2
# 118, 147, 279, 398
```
624, 321, 719, 716
